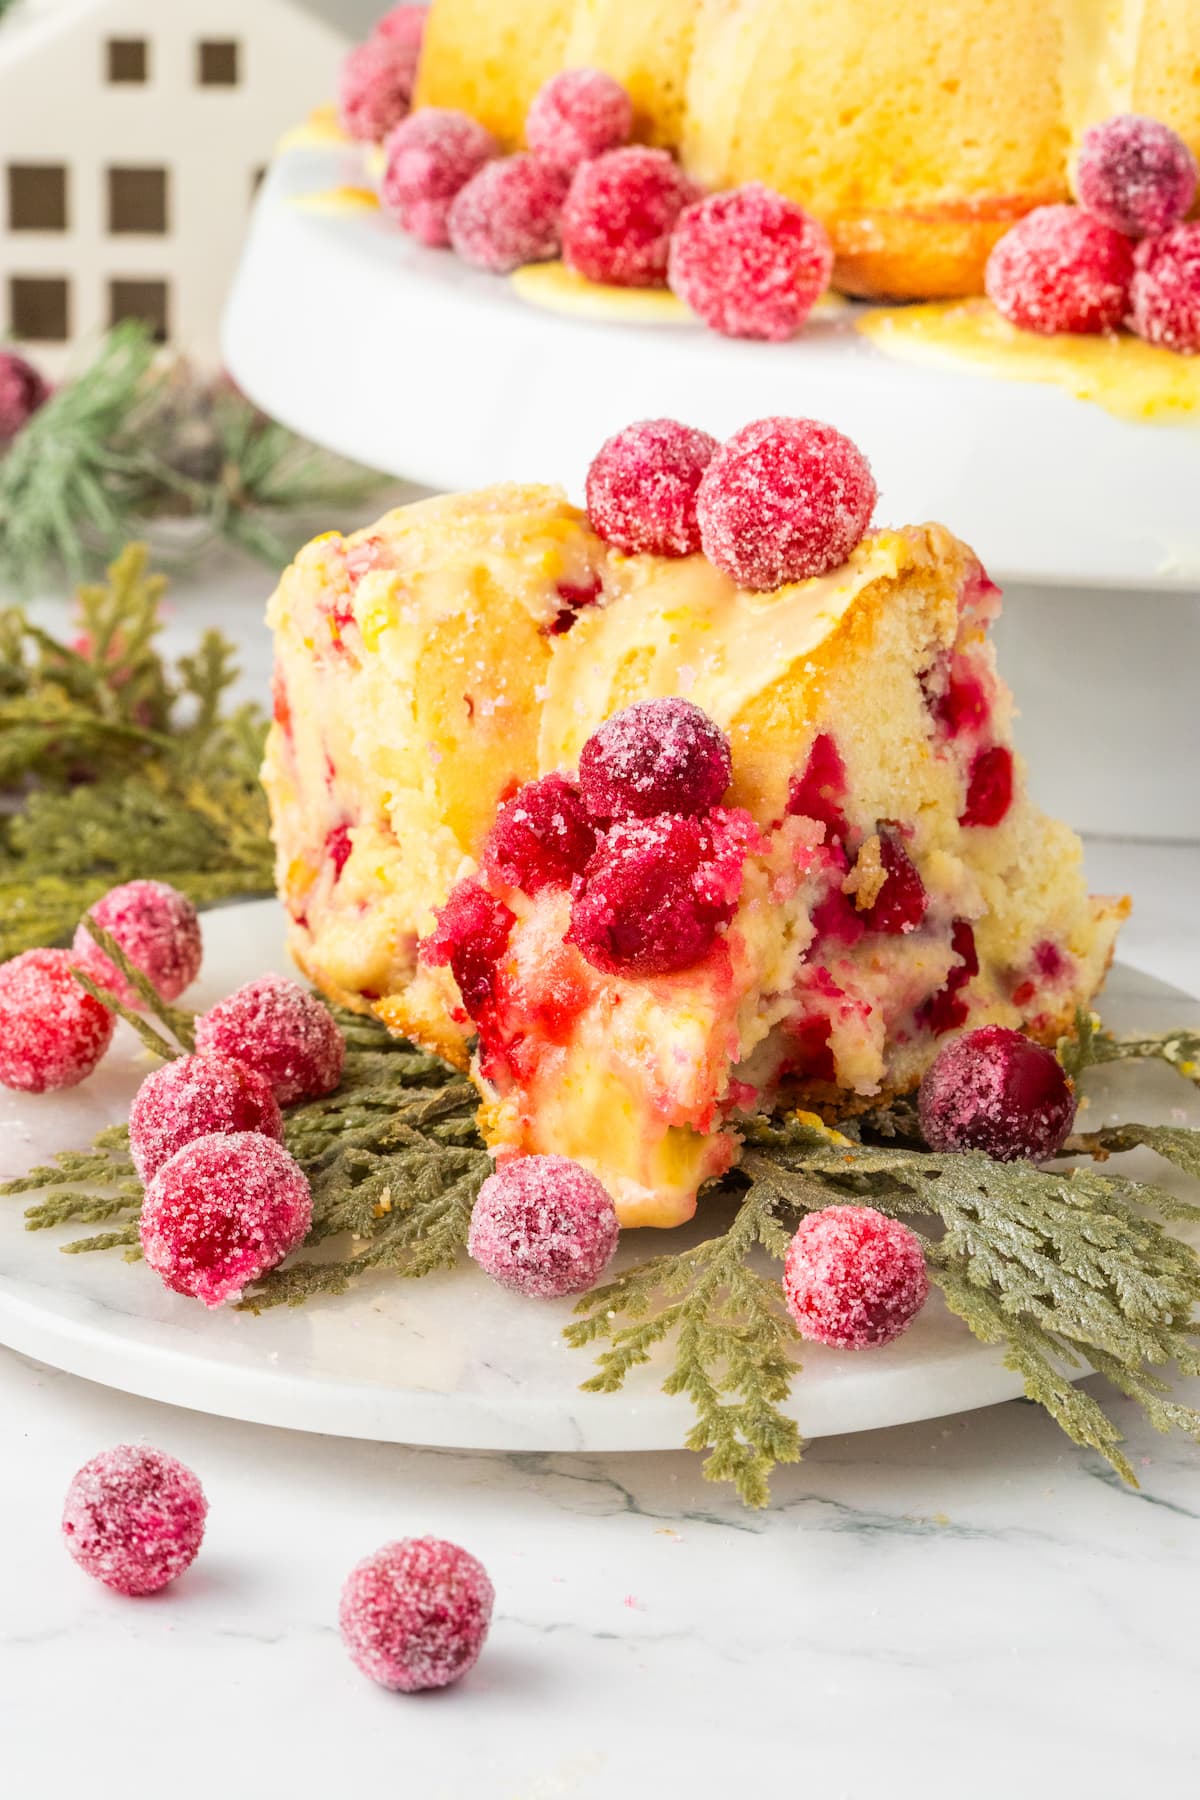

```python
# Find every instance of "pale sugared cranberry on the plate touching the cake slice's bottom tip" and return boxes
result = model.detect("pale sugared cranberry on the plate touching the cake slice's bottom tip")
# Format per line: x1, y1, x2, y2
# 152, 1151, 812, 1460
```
466, 1156, 619, 1300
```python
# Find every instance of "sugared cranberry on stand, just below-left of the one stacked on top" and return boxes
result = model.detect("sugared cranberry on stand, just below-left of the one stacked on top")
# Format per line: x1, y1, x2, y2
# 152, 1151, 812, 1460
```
448, 153, 570, 275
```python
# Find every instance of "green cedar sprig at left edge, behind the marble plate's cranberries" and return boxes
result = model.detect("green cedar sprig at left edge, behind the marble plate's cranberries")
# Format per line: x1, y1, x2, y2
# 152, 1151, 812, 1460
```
0, 544, 273, 959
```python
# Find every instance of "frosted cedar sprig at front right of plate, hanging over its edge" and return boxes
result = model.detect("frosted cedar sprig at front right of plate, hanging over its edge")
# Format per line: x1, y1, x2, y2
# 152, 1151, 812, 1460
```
567, 1108, 1200, 1505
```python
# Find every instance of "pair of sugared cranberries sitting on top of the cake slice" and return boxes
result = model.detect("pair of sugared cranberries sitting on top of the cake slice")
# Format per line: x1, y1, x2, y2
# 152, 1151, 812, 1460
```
587, 419, 878, 589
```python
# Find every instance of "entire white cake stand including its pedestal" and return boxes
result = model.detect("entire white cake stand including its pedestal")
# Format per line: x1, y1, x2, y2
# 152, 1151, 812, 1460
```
223, 146, 1200, 839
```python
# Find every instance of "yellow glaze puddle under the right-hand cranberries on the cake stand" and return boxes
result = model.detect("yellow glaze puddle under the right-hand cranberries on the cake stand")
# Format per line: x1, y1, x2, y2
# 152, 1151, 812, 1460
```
858, 301, 1200, 425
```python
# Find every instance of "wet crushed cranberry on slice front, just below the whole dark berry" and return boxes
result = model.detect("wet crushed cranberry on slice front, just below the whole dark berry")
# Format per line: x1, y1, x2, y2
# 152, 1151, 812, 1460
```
567, 808, 756, 976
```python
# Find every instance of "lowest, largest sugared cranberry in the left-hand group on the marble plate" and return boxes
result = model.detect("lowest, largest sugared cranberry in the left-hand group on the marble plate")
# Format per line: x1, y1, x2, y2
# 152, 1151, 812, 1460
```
139, 1130, 313, 1307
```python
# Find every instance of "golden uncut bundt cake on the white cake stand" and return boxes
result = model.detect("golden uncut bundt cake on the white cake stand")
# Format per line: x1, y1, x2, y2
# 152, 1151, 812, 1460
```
416, 0, 1200, 299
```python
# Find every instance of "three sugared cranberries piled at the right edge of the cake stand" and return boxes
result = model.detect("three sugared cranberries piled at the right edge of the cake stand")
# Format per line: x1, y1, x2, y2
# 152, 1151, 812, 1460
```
986, 113, 1200, 353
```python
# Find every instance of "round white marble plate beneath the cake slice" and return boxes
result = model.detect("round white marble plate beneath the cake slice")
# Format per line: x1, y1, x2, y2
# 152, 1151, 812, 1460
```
0, 902, 1200, 1451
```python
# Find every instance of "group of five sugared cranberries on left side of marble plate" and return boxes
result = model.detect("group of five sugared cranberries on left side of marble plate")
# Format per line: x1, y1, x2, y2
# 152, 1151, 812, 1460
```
0, 882, 345, 1307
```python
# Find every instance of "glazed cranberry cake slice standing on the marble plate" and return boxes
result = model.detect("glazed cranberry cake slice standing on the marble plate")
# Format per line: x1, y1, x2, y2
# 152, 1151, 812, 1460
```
264, 478, 1124, 1226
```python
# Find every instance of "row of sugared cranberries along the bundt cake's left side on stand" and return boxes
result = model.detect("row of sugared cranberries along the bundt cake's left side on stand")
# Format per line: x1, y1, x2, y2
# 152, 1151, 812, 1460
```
368, 58, 833, 340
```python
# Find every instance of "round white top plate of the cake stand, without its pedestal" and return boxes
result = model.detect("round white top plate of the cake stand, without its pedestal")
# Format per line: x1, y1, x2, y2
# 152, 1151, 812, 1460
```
221, 146, 1200, 594
